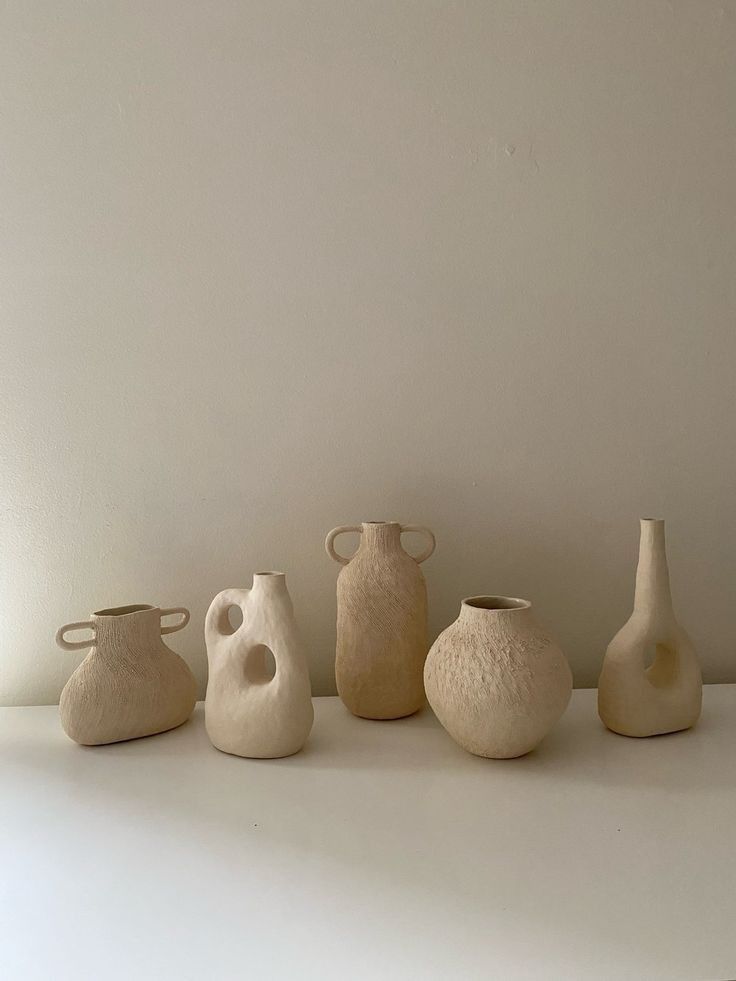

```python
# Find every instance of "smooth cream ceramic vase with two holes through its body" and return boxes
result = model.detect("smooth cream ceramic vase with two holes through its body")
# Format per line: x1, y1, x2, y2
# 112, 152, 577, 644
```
205, 572, 314, 759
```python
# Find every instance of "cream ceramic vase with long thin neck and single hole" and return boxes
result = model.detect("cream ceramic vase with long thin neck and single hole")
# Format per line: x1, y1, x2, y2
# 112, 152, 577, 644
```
598, 518, 703, 736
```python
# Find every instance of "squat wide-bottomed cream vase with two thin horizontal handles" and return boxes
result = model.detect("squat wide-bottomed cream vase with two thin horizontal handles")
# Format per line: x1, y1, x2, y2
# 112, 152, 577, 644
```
56, 605, 197, 746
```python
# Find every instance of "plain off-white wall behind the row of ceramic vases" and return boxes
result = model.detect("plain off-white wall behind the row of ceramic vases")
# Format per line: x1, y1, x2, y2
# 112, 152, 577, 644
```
0, 0, 736, 703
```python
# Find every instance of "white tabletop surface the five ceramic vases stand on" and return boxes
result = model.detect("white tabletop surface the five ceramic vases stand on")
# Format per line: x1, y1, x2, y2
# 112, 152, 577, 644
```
0, 686, 736, 981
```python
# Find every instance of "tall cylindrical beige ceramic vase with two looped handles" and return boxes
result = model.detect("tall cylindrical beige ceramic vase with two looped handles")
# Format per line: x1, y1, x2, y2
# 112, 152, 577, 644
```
325, 521, 435, 719
